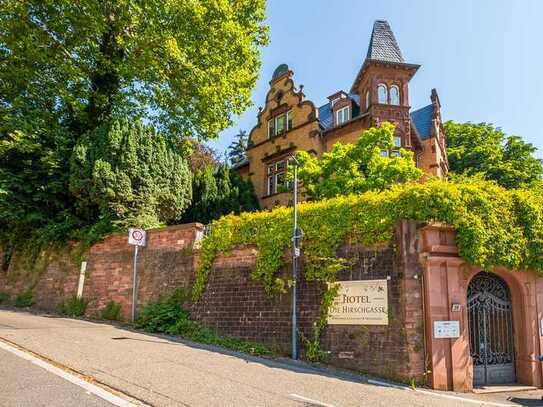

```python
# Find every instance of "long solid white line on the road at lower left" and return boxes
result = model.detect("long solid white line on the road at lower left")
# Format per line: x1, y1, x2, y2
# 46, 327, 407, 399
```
0, 341, 136, 407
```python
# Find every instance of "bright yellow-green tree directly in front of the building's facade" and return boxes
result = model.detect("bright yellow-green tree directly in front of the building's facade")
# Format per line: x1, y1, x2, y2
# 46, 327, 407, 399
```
296, 122, 422, 200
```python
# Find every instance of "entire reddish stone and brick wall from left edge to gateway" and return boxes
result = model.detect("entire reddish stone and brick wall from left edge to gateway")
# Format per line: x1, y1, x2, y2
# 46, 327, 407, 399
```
0, 223, 424, 380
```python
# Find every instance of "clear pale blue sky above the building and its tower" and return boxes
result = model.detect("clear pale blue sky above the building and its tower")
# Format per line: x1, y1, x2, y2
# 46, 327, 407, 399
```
211, 0, 543, 158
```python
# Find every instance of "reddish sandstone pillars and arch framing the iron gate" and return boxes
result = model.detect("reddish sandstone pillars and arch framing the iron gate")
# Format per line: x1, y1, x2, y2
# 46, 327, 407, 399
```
420, 225, 543, 392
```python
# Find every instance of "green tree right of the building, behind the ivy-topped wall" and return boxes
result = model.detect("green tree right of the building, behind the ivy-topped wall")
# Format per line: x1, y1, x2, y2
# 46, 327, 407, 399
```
445, 121, 543, 188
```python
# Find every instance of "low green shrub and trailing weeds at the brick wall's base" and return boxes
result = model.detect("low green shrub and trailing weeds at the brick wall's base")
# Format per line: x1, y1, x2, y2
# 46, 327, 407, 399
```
136, 290, 274, 355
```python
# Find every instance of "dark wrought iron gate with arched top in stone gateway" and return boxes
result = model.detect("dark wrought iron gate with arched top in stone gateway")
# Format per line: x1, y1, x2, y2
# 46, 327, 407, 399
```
468, 273, 516, 386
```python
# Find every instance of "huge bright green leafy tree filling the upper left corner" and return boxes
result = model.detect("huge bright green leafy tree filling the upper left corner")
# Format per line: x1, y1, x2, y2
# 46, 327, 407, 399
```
0, 0, 268, 138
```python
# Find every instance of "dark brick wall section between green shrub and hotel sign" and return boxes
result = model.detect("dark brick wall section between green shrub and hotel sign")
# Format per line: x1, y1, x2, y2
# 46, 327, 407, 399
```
191, 247, 323, 353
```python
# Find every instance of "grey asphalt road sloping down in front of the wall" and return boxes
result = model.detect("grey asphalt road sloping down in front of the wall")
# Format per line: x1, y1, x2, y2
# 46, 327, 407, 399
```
0, 310, 537, 407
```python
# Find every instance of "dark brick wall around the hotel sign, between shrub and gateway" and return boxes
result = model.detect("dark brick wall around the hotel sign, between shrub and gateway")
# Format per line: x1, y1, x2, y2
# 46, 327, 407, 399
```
192, 222, 425, 380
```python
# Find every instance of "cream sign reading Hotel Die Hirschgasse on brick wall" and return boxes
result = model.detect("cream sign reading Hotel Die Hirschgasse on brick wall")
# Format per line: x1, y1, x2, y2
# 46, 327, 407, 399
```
328, 280, 388, 325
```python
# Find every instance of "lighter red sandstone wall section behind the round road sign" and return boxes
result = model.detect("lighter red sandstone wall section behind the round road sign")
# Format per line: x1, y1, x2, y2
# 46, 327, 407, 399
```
83, 224, 203, 317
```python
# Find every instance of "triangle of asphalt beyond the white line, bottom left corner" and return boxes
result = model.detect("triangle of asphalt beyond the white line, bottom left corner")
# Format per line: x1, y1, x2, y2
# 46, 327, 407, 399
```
0, 349, 111, 407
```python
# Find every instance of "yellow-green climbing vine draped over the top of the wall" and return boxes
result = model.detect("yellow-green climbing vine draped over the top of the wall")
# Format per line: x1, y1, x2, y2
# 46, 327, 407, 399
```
193, 180, 543, 301
